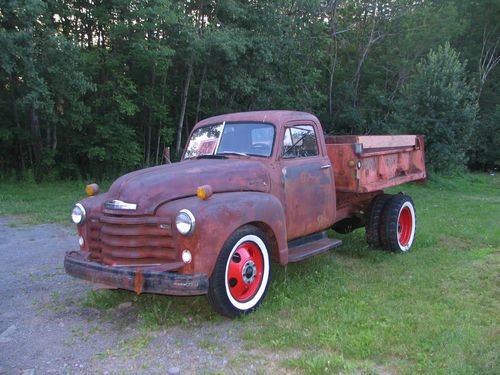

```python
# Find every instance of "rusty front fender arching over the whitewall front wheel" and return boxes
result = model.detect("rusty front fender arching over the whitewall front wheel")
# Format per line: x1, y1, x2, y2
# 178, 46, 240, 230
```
157, 192, 288, 275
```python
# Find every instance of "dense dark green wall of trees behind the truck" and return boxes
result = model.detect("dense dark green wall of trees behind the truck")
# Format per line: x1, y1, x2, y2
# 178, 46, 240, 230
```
0, 0, 500, 179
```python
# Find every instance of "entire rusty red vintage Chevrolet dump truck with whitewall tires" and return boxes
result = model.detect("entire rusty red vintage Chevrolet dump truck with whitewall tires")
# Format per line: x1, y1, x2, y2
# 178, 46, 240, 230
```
64, 111, 426, 317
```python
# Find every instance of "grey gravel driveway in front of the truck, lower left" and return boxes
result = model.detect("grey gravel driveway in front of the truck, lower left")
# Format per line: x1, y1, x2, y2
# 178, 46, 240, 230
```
0, 217, 286, 374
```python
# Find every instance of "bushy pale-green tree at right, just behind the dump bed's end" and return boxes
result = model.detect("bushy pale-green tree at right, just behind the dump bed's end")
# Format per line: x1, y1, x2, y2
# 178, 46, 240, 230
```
393, 43, 477, 173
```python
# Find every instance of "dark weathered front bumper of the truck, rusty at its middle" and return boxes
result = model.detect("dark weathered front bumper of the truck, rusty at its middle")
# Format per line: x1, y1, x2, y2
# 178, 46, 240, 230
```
64, 251, 208, 296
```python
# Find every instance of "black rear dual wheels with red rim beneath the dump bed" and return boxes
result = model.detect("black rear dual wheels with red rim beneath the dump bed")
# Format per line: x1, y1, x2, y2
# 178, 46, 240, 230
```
366, 193, 417, 253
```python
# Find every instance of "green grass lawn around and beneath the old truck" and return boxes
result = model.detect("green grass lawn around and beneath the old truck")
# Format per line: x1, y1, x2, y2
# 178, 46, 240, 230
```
0, 174, 500, 374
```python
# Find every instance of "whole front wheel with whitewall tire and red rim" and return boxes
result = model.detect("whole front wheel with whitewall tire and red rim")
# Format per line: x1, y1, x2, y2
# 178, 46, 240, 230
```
208, 225, 271, 318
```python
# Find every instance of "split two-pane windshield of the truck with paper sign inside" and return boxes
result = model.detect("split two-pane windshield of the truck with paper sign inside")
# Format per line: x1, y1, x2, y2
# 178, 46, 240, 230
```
184, 122, 274, 159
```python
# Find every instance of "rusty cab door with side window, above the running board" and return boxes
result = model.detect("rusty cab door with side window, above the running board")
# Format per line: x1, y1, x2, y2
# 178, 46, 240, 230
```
280, 124, 335, 240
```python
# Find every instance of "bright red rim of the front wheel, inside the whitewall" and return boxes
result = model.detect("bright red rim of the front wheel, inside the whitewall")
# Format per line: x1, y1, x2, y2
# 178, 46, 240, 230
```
226, 242, 264, 302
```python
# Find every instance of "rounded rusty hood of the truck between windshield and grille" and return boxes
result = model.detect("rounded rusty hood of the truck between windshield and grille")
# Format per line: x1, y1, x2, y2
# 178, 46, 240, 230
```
105, 159, 270, 215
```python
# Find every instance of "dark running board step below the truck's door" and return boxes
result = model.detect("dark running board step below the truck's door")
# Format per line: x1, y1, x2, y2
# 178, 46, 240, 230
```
288, 232, 342, 262
